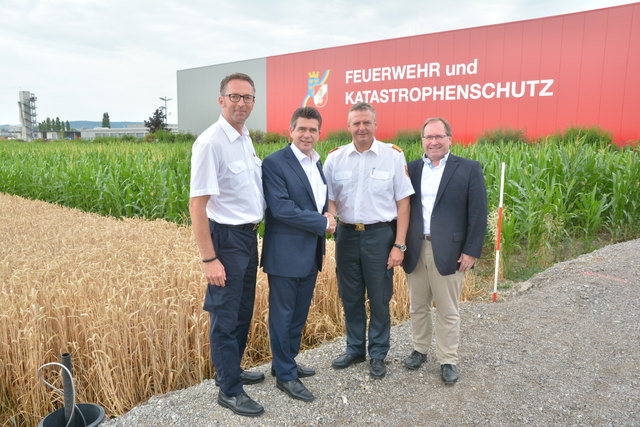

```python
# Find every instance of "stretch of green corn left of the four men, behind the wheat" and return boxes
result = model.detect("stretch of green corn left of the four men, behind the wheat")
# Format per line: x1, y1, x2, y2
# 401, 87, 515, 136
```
0, 142, 191, 224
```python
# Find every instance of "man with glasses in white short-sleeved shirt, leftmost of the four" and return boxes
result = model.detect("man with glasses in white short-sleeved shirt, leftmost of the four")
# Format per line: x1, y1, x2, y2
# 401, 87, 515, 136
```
189, 73, 265, 416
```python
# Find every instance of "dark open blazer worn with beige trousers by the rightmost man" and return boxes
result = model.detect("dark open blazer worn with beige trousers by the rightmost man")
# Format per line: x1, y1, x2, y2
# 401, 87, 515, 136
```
403, 154, 487, 276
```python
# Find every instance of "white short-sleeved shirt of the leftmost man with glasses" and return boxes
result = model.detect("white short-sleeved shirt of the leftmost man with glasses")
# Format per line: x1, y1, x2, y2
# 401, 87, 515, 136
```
189, 115, 266, 225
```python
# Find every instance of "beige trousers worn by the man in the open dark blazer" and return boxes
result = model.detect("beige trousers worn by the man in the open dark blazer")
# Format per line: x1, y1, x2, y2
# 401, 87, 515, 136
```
407, 241, 464, 365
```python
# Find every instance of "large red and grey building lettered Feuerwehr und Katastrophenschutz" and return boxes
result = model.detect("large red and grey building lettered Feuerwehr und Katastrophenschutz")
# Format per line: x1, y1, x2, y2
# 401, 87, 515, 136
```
177, 3, 640, 144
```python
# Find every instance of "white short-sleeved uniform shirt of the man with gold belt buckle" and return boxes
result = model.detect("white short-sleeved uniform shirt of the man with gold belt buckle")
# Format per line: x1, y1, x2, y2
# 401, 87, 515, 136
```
324, 139, 414, 224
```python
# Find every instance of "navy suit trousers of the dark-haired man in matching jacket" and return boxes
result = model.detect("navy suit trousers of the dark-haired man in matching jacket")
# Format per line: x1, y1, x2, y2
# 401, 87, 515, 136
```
268, 265, 318, 381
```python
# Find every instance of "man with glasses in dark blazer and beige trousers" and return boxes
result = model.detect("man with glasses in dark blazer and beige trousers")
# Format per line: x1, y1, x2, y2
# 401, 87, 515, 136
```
403, 118, 487, 385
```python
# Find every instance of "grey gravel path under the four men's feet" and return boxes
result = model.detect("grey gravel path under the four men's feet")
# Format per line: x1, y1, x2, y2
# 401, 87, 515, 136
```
103, 240, 640, 427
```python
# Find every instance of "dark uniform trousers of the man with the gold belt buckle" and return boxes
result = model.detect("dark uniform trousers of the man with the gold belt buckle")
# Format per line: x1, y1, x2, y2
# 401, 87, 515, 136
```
336, 225, 396, 359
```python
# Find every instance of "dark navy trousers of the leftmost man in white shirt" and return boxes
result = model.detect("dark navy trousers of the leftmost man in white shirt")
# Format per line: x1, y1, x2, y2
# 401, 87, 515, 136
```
204, 221, 258, 396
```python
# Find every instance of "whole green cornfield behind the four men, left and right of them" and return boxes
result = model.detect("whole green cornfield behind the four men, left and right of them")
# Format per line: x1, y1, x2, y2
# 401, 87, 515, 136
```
0, 137, 640, 251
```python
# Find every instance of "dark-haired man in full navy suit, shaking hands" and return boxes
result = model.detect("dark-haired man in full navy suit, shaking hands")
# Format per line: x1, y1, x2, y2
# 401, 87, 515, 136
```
261, 107, 336, 402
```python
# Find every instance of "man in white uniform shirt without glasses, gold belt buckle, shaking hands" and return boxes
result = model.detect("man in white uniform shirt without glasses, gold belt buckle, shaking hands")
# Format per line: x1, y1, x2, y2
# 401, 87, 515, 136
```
324, 102, 413, 378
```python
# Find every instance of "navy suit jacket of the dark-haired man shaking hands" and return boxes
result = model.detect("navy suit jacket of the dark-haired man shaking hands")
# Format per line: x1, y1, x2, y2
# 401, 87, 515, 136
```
260, 144, 328, 277
